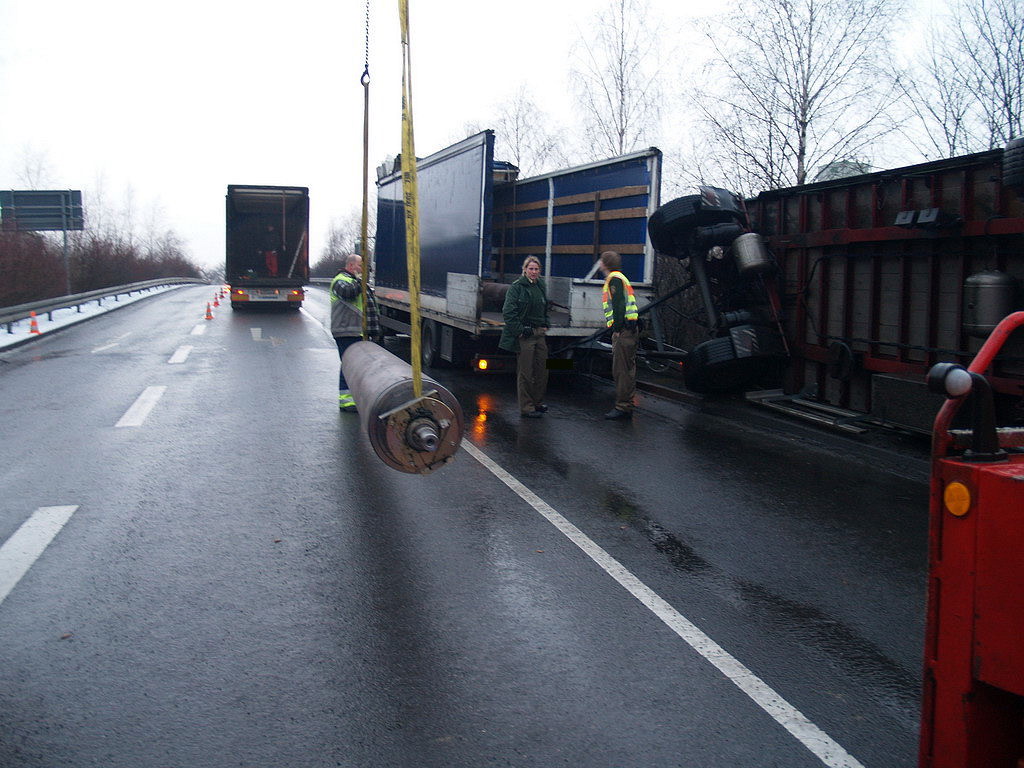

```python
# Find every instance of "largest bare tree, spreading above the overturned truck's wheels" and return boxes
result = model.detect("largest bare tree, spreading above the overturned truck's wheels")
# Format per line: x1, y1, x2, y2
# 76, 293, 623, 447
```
692, 0, 900, 191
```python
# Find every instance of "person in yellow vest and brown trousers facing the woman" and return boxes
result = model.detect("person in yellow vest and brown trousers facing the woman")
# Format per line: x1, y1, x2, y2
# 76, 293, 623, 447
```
599, 251, 640, 419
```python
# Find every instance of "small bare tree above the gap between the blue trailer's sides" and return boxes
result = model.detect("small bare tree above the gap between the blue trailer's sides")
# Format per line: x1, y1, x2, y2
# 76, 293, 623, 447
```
495, 85, 568, 176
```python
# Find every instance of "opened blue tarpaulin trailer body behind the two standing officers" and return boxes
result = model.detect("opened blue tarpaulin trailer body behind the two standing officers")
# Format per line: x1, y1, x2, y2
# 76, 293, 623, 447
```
374, 130, 662, 368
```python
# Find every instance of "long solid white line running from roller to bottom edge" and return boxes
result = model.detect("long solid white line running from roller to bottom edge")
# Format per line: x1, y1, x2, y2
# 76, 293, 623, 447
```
462, 440, 864, 768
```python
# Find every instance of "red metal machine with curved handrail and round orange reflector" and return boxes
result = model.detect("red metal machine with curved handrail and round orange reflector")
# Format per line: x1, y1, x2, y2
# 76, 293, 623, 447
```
919, 312, 1024, 768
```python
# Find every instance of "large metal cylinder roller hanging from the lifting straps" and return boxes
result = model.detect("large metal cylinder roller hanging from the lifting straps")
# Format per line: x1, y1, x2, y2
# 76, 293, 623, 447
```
341, 341, 465, 474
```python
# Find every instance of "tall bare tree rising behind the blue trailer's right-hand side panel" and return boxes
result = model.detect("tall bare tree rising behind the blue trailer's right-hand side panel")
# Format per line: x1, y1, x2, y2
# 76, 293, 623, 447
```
570, 0, 662, 159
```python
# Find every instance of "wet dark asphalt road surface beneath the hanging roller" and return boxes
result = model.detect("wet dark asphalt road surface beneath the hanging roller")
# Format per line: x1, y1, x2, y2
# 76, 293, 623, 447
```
0, 288, 927, 768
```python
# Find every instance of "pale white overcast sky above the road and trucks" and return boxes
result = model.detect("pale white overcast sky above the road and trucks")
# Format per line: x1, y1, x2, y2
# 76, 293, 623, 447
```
0, 0, 933, 266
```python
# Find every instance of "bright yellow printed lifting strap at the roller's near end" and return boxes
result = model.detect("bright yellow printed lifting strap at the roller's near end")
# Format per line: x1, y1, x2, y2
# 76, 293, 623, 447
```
398, 0, 423, 398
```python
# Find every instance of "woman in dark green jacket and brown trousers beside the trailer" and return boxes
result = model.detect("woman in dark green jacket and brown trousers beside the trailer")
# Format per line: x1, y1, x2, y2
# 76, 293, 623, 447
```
498, 256, 551, 419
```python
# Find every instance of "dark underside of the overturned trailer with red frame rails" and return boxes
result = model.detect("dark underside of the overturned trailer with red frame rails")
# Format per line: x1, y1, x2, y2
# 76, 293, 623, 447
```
746, 140, 1024, 432
